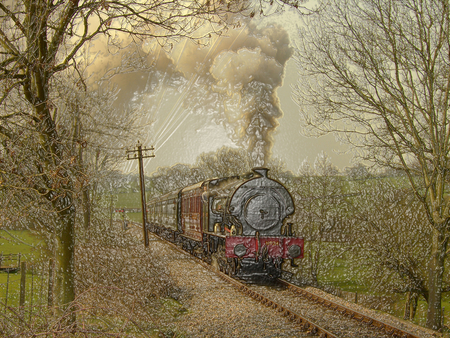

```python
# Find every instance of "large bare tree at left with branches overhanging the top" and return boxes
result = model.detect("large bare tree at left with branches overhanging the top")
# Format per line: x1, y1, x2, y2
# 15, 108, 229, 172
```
0, 0, 308, 328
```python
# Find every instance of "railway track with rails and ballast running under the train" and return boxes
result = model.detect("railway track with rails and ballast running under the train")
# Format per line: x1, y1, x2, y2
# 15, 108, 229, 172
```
129, 223, 431, 338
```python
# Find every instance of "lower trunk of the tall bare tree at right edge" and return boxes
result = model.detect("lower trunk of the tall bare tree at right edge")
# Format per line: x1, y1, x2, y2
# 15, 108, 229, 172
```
426, 229, 448, 330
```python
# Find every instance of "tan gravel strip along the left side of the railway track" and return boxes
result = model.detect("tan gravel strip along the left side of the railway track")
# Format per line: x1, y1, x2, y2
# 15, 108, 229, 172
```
144, 235, 311, 338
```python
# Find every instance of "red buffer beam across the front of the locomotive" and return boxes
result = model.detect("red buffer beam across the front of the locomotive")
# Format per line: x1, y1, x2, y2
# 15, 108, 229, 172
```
225, 236, 303, 258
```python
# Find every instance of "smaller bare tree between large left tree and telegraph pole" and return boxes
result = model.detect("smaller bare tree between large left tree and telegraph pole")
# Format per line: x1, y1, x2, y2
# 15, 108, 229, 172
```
54, 66, 141, 229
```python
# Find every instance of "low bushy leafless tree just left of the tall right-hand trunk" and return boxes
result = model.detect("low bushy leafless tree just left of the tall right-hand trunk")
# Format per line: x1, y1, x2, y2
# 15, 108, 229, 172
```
347, 177, 432, 319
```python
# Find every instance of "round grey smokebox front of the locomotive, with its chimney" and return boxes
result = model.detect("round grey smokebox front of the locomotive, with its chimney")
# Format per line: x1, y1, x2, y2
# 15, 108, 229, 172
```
229, 168, 294, 236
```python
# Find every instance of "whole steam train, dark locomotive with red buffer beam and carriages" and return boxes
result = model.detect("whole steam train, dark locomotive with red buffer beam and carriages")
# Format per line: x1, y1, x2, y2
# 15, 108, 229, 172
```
147, 168, 303, 282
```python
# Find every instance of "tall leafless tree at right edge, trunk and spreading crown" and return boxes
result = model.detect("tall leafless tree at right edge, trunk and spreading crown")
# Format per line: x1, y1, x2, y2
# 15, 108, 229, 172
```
294, 0, 450, 329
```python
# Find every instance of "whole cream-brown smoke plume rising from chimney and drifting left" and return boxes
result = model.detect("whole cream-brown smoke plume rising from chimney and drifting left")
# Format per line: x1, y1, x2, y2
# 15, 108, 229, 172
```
107, 22, 292, 166
